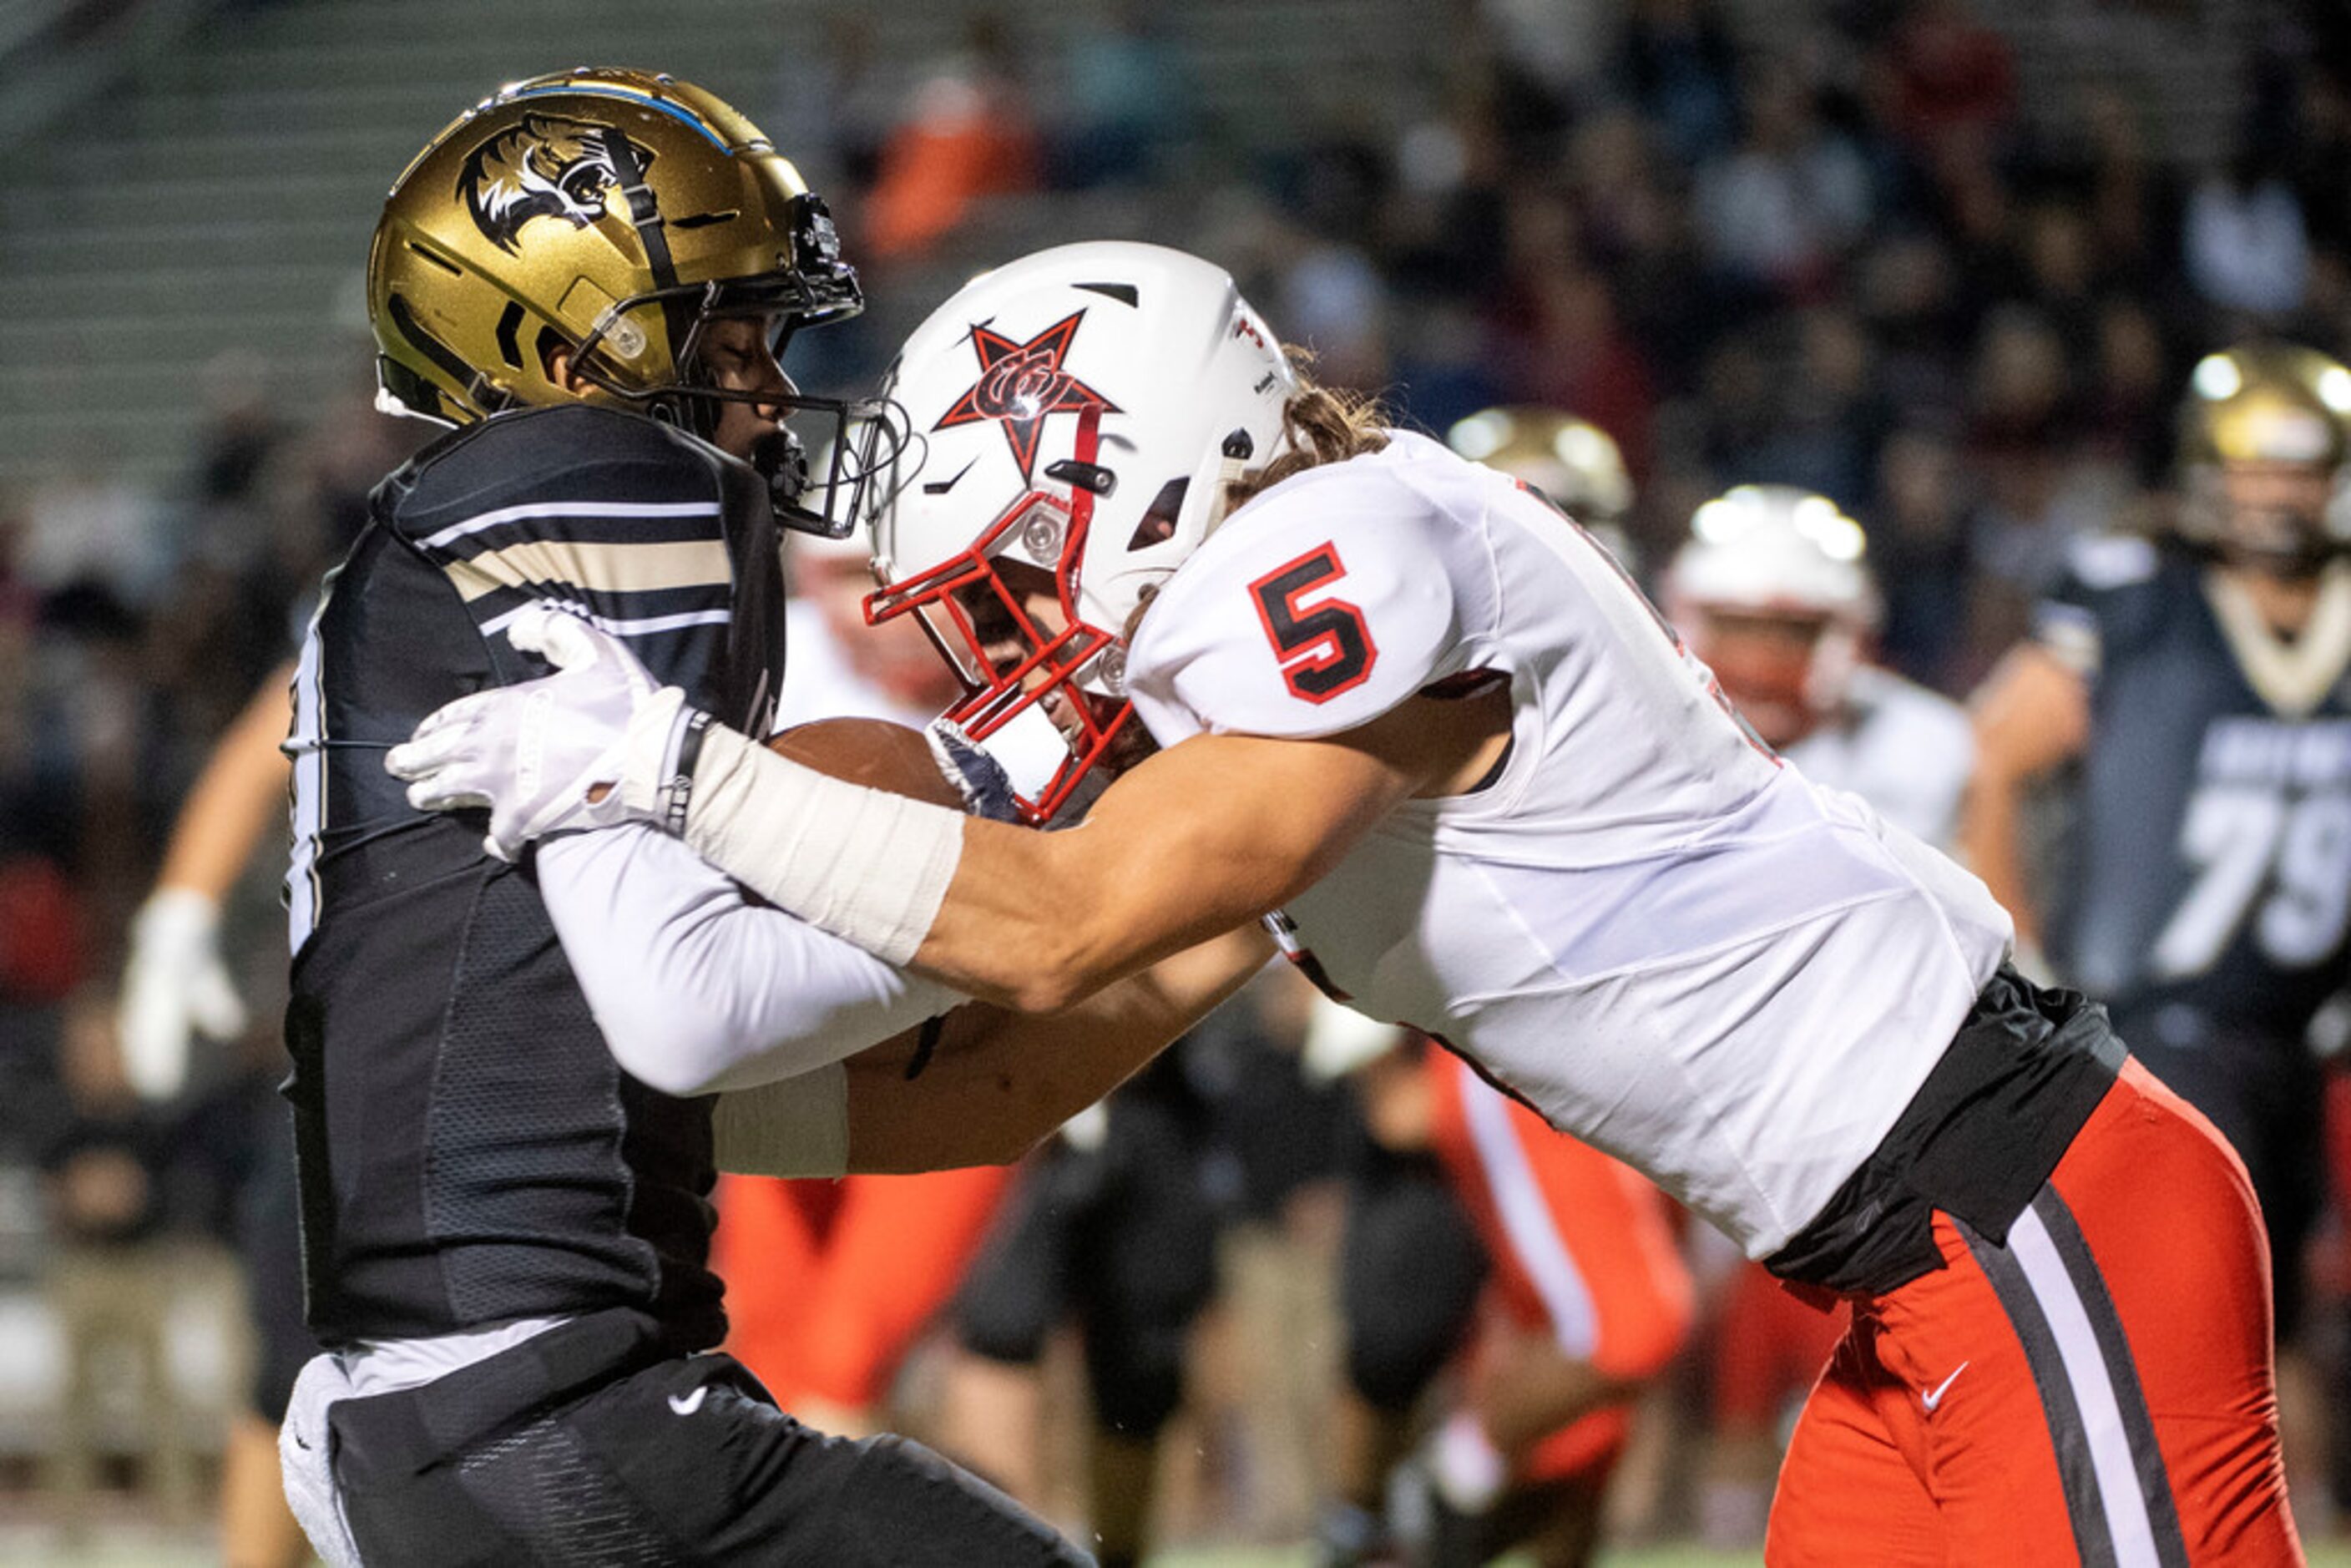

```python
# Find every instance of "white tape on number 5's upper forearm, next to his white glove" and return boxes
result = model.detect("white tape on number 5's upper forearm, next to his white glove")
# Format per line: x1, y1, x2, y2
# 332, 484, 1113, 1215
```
686, 724, 964, 966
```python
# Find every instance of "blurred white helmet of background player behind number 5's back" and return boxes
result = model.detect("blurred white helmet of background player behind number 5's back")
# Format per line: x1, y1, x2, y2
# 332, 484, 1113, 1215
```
1665, 484, 1878, 746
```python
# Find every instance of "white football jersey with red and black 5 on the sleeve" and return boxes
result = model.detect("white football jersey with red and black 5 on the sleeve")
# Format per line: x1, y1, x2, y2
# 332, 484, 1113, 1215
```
1129, 432, 2010, 1257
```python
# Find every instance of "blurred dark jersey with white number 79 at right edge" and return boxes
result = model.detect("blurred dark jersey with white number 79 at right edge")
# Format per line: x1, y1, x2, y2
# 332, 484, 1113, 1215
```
2038, 541, 2351, 1044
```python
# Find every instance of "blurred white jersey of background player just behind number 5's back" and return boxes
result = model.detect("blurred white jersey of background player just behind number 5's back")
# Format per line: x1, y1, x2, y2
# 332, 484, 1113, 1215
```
1780, 665, 1974, 848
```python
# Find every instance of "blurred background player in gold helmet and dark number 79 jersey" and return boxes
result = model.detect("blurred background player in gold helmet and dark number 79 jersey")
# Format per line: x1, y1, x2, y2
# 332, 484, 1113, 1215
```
1963, 343, 2351, 1523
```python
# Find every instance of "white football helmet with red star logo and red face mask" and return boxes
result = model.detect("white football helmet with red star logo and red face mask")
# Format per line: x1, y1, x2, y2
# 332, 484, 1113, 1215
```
865, 242, 1297, 821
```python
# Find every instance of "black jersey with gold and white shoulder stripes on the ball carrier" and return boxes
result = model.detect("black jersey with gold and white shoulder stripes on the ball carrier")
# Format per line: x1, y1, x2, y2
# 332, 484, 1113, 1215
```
287, 407, 783, 1345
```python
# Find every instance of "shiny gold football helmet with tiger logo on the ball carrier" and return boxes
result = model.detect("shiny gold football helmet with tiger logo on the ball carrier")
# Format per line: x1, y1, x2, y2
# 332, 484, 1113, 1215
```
367, 68, 884, 534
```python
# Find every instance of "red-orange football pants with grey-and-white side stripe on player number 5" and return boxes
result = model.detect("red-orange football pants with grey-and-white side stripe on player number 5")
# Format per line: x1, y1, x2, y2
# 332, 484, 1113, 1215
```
1763, 1060, 2302, 1568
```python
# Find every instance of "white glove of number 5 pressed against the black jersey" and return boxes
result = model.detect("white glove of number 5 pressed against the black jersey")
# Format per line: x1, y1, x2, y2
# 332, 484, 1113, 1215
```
383, 602, 696, 861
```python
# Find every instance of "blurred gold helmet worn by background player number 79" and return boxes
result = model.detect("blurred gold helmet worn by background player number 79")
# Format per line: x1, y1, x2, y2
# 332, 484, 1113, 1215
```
2179, 343, 2351, 574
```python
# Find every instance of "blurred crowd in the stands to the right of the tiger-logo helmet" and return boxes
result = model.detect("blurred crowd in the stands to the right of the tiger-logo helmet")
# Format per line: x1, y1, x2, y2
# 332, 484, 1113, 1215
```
785, 0, 2351, 691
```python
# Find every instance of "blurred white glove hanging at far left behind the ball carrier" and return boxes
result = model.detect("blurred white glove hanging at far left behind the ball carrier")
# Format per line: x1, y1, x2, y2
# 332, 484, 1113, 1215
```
115, 888, 245, 1100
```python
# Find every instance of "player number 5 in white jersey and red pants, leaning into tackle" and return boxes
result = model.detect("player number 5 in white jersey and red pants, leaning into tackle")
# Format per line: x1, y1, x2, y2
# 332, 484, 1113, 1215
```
388, 245, 2299, 1563
